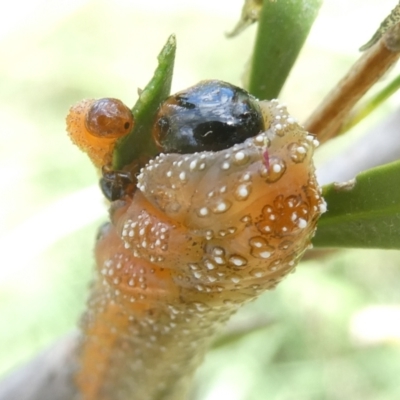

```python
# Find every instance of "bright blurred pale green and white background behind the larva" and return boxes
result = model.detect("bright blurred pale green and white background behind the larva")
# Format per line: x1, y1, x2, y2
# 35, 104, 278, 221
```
0, 0, 400, 400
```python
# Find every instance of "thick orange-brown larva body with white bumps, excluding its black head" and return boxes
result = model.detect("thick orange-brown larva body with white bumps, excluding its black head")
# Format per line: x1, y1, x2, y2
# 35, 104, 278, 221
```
77, 101, 326, 400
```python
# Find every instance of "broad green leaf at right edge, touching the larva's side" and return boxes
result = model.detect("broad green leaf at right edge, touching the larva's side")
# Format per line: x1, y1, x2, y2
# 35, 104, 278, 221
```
313, 161, 400, 249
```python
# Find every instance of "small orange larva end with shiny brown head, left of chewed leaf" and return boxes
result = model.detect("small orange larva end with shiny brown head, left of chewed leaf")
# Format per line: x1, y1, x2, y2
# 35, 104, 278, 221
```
67, 98, 134, 167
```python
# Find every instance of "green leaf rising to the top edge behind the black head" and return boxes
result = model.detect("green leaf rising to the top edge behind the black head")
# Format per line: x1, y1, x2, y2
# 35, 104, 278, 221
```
248, 0, 322, 100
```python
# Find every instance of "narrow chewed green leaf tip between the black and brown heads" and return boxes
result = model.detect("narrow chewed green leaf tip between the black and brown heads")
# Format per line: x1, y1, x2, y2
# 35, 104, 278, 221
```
112, 35, 176, 170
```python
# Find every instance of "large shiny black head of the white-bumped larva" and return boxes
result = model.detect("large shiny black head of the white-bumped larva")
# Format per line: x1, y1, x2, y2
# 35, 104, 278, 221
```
153, 81, 264, 154
